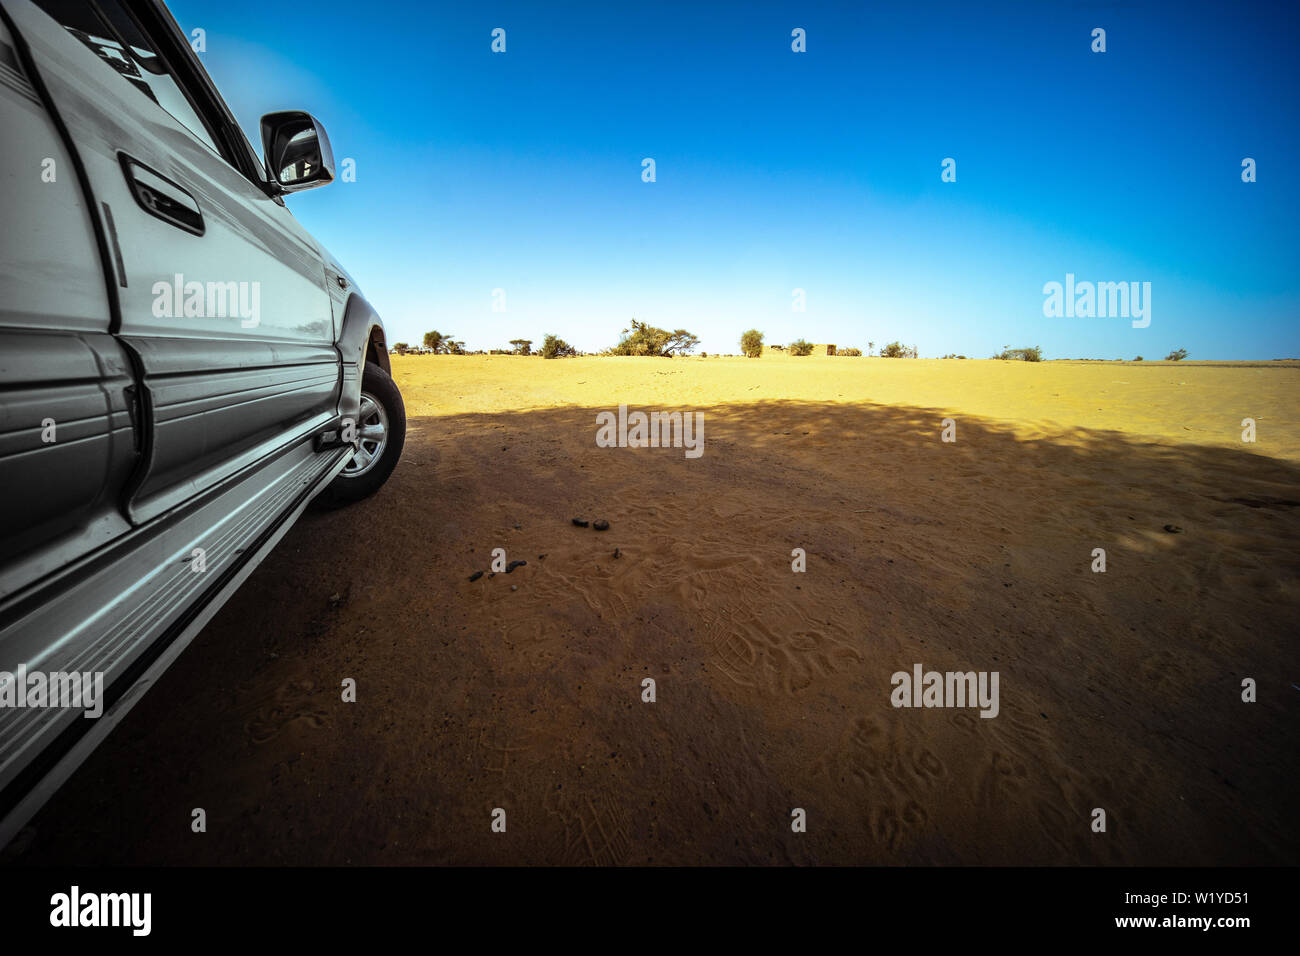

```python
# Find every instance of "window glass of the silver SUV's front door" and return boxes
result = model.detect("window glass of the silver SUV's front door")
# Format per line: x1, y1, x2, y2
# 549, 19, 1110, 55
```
36, 0, 220, 152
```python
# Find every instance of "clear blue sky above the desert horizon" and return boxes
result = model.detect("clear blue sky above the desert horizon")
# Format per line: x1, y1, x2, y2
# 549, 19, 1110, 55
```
170, 0, 1300, 359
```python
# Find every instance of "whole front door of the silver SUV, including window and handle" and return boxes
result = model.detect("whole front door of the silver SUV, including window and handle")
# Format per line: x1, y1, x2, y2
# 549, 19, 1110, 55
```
17, 0, 339, 523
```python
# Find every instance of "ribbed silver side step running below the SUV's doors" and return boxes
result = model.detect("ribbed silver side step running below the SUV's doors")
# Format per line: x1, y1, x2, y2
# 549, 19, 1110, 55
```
0, 442, 348, 847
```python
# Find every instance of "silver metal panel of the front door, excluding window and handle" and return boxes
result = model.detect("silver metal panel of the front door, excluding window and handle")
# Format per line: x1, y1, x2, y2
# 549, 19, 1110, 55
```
7, 1, 339, 522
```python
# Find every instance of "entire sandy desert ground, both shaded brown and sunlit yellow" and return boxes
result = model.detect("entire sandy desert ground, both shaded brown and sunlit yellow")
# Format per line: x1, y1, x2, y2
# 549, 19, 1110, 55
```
9, 356, 1300, 865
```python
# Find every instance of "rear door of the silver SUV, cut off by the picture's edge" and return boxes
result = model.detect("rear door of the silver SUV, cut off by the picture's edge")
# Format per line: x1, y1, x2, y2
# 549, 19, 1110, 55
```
0, 9, 137, 598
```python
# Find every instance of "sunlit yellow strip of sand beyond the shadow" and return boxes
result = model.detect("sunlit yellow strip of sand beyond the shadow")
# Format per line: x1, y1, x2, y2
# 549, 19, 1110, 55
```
393, 355, 1300, 460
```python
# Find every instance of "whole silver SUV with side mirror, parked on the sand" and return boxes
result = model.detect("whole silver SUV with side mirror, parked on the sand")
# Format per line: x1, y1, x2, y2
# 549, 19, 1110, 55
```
0, 0, 406, 845
